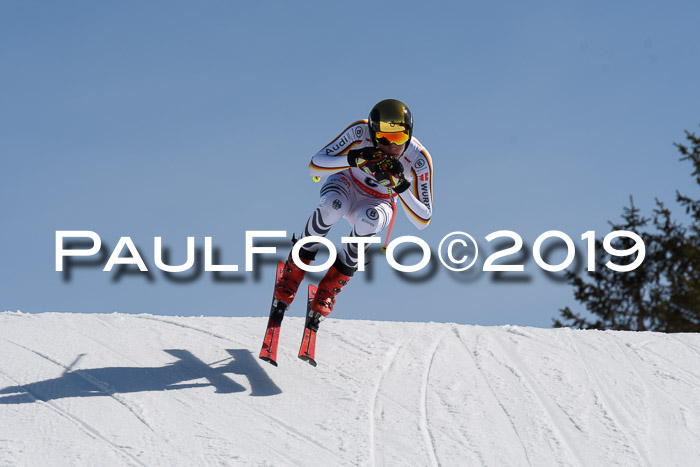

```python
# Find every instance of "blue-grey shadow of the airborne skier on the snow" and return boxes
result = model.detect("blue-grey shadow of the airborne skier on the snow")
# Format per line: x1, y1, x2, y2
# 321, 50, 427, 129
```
0, 349, 282, 404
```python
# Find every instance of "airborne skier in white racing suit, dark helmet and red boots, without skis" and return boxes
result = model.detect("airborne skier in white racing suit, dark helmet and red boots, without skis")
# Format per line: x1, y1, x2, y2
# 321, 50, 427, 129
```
274, 99, 433, 331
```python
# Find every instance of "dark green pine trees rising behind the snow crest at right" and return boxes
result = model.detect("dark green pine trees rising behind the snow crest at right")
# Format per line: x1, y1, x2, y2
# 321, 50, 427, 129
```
553, 131, 700, 332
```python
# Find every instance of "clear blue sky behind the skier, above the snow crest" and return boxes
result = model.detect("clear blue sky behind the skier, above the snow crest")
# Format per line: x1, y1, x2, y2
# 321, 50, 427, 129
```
0, 1, 700, 326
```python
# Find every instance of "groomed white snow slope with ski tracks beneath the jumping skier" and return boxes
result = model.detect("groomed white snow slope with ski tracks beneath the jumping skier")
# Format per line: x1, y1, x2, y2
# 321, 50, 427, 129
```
0, 313, 700, 466
